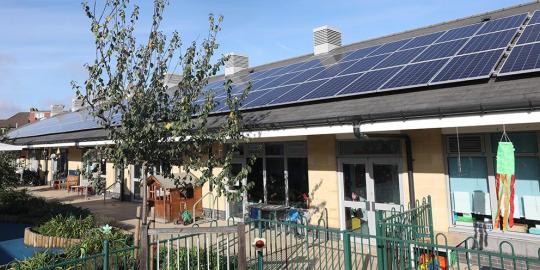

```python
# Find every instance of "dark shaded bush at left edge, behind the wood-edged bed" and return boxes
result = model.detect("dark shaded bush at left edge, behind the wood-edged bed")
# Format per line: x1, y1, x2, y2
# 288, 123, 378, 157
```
0, 190, 91, 226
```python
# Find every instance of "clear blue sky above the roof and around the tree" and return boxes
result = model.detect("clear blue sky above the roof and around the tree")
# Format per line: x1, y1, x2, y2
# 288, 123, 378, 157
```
0, 0, 528, 119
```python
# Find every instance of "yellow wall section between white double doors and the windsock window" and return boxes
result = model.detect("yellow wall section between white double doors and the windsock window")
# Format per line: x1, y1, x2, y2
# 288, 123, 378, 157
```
408, 129, 450, 232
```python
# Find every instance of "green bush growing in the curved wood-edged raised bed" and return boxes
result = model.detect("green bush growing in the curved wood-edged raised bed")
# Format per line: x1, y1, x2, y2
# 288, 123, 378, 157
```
33, 214, 95, 239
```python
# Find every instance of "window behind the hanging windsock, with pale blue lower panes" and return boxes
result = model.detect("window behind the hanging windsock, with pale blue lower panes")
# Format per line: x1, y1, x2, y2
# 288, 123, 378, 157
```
447, 132, 540, 232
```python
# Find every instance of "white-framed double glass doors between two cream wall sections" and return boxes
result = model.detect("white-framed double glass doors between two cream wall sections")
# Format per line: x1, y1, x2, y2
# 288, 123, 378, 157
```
339, 158, 403, 234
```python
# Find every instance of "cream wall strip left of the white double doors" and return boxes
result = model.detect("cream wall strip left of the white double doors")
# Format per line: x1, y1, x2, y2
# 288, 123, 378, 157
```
307, 135, 340, 228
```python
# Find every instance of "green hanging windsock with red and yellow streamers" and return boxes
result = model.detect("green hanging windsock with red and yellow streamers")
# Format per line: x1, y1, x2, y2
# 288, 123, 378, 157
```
493, 141, 516, 230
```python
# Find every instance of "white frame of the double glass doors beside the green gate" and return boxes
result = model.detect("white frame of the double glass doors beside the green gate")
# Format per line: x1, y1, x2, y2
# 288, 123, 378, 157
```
338, 157, 404, 234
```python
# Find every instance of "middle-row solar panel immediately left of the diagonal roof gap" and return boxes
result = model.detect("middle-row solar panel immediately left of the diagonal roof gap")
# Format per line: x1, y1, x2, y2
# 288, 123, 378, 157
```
458, 29, 517, 54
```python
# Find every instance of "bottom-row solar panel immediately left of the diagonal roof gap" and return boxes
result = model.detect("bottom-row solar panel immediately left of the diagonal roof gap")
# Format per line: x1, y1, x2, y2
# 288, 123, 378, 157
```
431, 49, 504, 84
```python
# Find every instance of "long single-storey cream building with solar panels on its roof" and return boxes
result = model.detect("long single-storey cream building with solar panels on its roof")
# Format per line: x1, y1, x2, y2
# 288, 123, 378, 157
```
6, 2, 540, 255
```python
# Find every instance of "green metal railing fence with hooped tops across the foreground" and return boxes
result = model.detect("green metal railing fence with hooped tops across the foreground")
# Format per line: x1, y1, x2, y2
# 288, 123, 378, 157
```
7, 195, 540, 270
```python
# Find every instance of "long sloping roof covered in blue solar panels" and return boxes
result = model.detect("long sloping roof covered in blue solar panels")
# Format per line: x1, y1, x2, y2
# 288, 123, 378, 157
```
8, 3, 540, 142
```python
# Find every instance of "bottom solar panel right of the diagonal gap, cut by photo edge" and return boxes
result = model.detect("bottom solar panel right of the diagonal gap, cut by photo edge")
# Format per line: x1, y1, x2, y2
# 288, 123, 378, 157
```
499, 43, 540, 75
